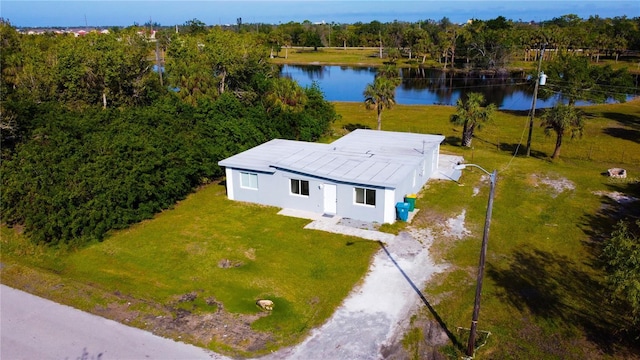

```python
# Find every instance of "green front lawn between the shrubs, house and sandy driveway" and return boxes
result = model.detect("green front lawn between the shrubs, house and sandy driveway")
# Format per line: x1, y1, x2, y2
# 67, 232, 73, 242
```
2, 184, 380, 351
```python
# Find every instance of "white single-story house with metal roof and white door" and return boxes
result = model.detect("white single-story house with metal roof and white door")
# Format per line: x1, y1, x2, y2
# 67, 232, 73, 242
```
218, 129, 444, 223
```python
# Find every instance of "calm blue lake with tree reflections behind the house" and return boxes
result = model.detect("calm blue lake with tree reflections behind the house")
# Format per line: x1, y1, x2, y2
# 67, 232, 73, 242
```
280, 65, 636, 110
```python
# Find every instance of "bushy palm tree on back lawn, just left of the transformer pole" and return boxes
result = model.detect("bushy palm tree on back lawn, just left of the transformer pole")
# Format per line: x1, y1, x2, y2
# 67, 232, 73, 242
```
450, 93, 496, 147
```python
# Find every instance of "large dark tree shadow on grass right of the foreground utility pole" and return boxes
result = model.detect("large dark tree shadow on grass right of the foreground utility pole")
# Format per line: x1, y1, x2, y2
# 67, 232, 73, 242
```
487, 246, 615, 355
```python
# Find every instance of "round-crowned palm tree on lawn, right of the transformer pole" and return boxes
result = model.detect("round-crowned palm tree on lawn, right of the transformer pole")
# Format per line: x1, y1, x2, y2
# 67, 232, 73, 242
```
540, 103, 584, 159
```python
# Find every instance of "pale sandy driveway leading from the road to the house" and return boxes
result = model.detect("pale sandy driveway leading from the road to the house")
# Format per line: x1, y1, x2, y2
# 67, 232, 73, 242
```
261, 231, 444, 360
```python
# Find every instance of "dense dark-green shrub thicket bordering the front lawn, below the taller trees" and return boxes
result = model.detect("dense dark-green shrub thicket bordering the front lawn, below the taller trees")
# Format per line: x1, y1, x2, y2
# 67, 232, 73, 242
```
0, 89, 335, 244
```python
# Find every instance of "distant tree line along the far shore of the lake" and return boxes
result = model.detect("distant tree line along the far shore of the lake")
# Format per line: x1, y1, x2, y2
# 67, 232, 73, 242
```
164, 14, 640, 68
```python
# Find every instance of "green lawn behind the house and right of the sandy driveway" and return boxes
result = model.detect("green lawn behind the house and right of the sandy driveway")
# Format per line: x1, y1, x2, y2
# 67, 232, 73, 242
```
335, 100, 640, 359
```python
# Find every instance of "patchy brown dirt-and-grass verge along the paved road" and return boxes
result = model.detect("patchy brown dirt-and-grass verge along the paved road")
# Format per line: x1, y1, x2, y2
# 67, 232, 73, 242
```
2, 261, 277, 356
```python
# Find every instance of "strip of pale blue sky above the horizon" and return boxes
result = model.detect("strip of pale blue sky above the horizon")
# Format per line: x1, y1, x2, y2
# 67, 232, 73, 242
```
0, 0, 640, 27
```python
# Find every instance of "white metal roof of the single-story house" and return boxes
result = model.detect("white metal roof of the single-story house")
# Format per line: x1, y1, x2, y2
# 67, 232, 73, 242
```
219, 129, 444, 188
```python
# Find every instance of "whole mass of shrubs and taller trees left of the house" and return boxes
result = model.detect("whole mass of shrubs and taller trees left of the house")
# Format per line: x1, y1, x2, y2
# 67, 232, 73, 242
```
0, 21, 337, 245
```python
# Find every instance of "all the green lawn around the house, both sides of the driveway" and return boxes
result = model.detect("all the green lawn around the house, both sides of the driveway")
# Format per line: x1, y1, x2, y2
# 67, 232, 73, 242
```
0, 97, 640, 359
